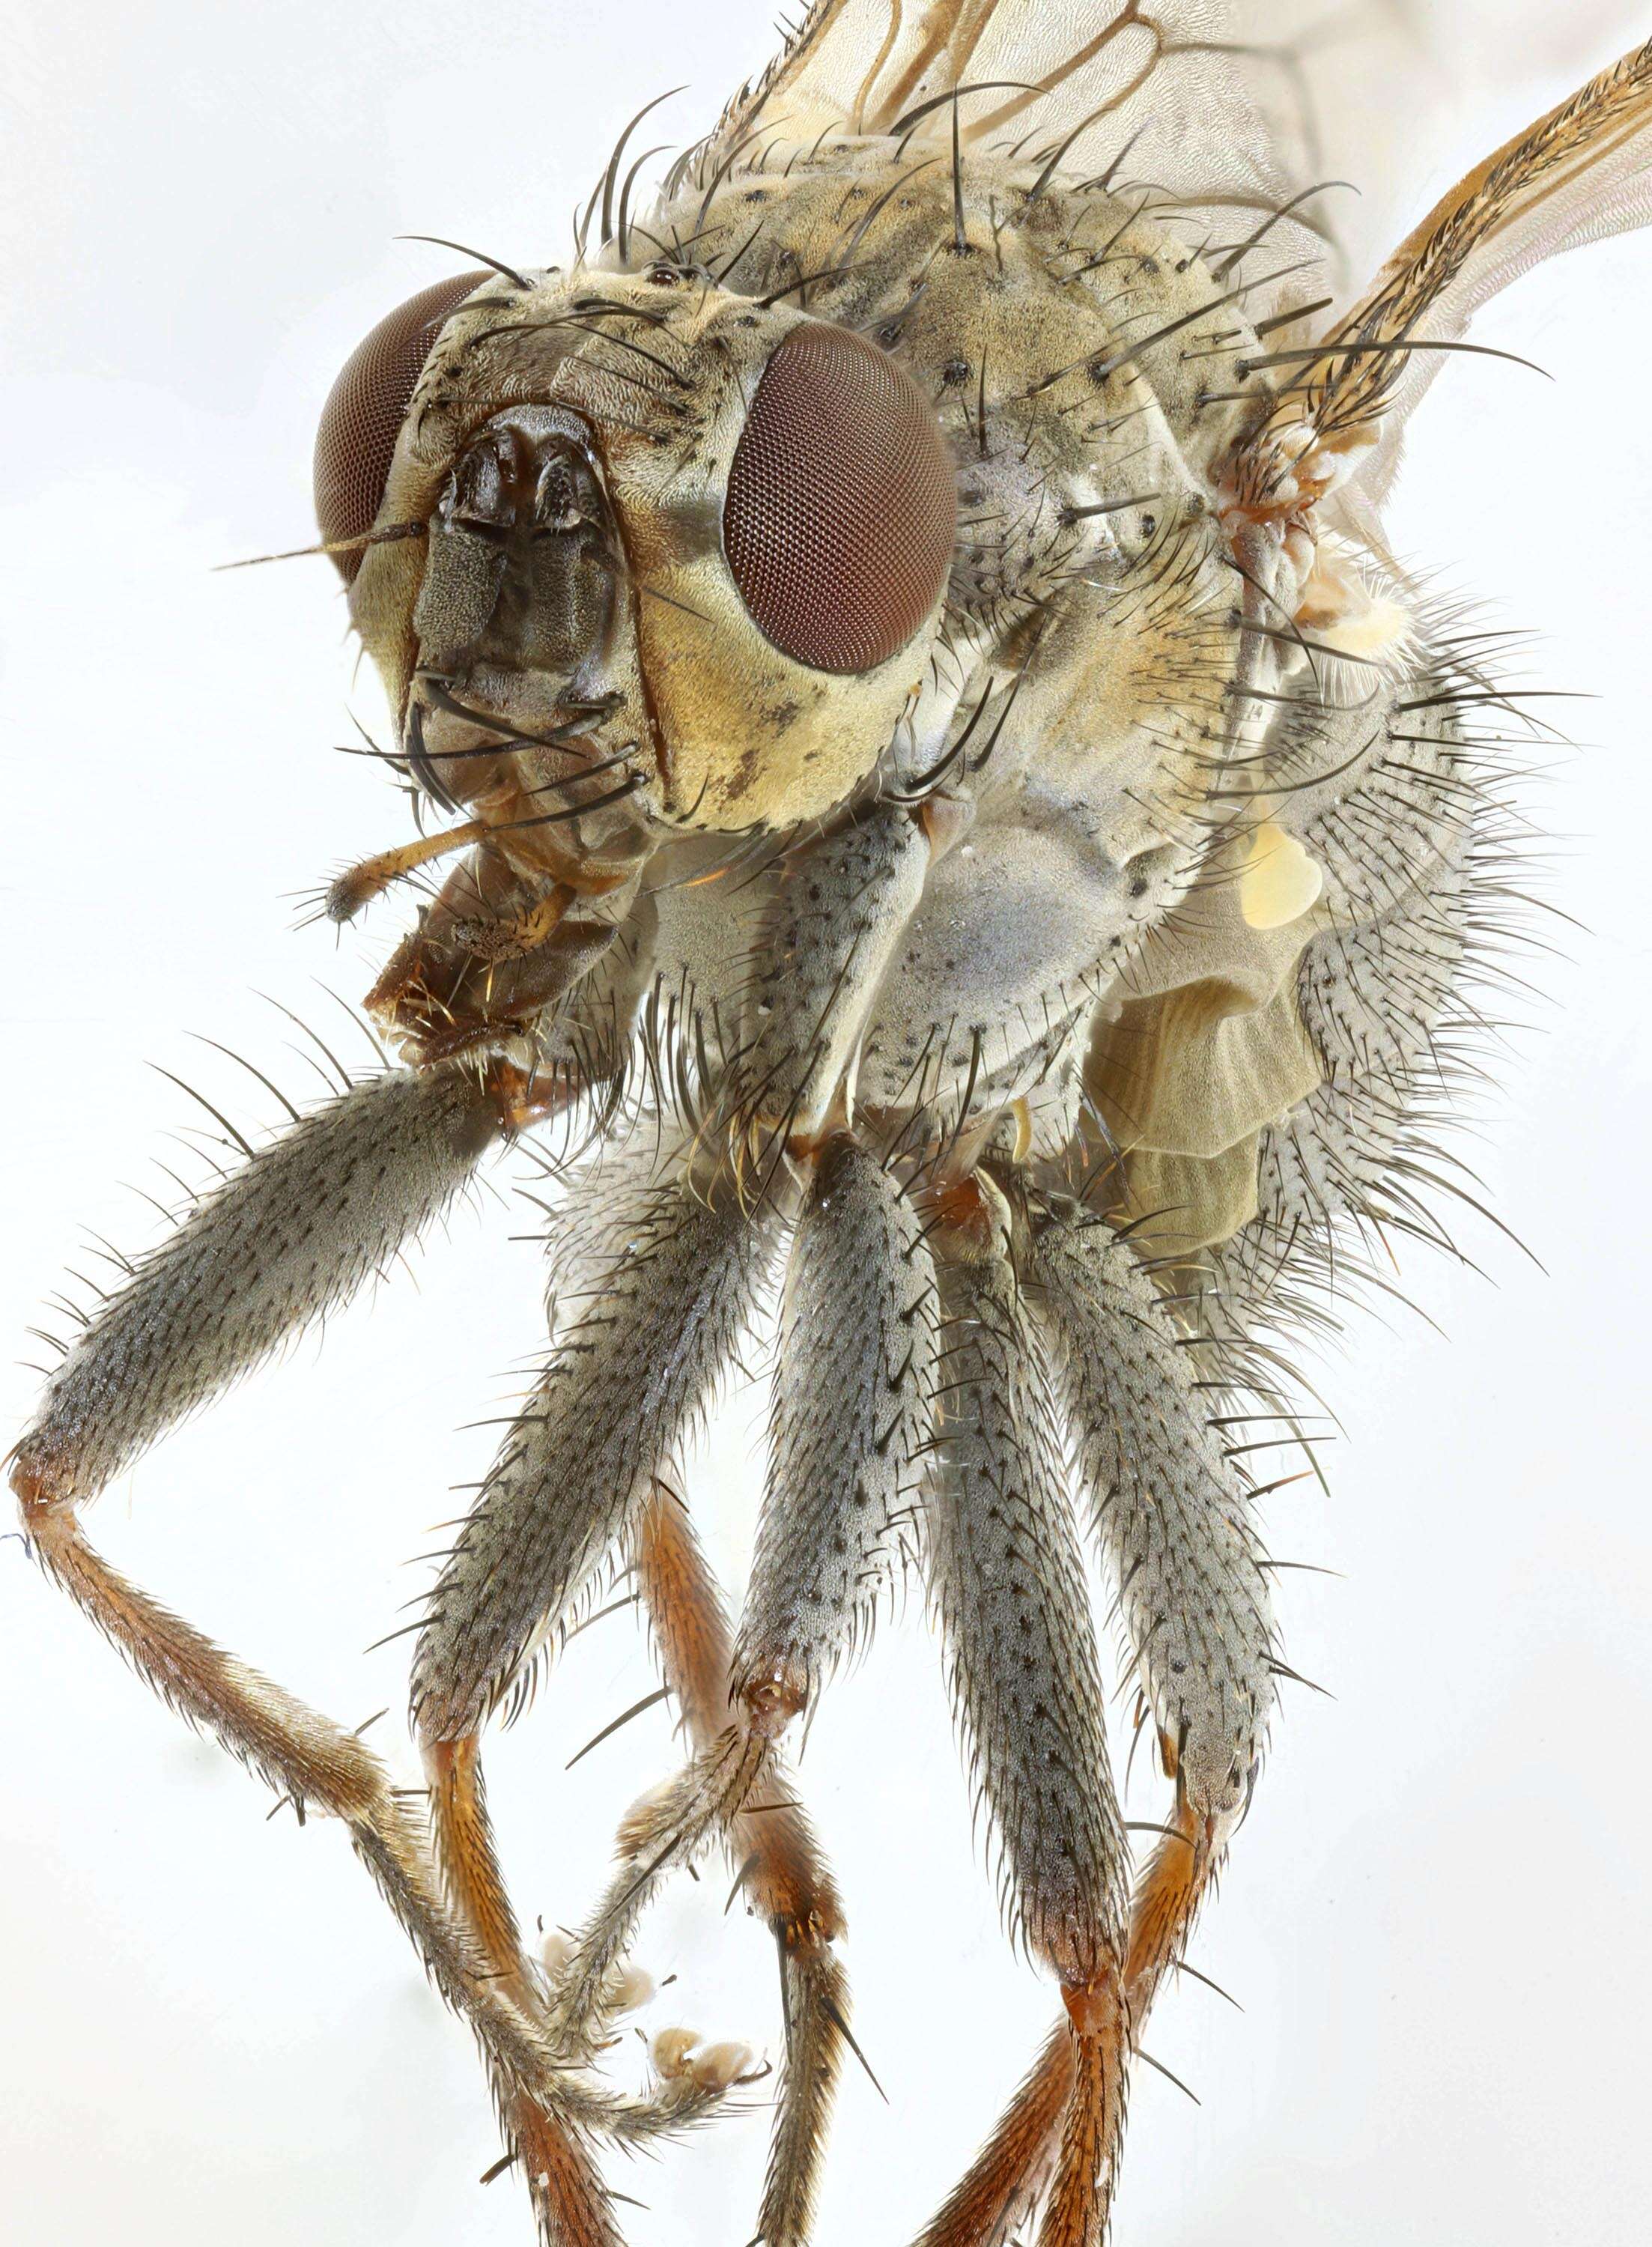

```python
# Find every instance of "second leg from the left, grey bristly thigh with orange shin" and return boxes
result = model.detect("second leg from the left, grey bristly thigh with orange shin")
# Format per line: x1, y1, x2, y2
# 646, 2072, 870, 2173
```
413, 1164, 768, 2247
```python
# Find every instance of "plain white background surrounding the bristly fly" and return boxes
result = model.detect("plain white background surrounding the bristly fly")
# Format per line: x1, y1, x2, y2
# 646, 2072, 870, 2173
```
0, 0, 1652, 2247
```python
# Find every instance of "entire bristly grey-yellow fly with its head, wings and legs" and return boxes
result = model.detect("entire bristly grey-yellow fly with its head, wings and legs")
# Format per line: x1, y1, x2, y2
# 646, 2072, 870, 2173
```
13, 0, 1652, 2247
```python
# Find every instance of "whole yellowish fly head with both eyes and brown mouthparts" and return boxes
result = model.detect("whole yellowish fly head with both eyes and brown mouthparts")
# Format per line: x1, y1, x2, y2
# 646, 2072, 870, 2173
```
317, 265, 956, 1061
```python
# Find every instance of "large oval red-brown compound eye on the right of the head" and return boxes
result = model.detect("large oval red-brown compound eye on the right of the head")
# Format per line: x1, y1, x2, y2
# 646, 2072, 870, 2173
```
723, 321, 958, 672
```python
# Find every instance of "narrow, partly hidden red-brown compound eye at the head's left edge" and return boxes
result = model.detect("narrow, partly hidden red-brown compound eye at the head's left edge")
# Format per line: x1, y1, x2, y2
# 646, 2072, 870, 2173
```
315, 272, 492, 584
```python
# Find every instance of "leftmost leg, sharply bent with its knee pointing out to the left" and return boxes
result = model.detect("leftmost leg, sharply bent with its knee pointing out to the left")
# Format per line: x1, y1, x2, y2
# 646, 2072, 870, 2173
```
11, 1074, 575, 2083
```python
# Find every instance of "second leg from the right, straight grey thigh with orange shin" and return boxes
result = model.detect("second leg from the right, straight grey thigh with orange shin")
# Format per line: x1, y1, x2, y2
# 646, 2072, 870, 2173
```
926, 1180, 1131, 2247
